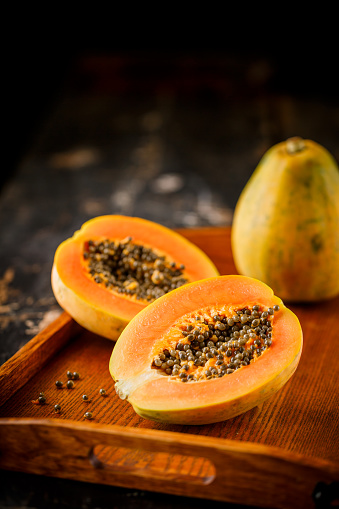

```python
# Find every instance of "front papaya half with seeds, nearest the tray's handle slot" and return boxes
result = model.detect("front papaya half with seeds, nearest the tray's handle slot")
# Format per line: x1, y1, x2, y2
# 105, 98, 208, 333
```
109, 275, 303, 425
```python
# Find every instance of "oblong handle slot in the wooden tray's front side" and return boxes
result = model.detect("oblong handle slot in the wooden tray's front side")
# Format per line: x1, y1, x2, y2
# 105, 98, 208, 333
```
89, 444, 216, 486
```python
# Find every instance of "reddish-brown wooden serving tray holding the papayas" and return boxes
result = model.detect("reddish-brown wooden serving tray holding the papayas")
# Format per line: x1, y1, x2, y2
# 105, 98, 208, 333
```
0, 228, 339, 509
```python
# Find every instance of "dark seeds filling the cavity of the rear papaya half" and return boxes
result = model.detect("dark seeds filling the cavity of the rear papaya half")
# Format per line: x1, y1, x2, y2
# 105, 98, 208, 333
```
83, 237, 188, 302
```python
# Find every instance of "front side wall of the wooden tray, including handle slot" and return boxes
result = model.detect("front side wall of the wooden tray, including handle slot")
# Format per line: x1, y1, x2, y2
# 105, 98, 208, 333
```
0, 418, 339, 509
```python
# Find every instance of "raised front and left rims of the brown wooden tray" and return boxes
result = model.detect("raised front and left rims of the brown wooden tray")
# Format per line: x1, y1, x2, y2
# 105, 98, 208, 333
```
0, 312, 339, 509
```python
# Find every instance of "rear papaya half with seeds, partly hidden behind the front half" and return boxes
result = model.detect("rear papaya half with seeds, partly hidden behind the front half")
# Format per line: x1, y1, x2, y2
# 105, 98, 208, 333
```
51, 215, 219, 341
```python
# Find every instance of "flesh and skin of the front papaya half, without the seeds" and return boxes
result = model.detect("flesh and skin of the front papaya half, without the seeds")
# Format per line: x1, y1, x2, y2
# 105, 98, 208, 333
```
109, 275, 303, 425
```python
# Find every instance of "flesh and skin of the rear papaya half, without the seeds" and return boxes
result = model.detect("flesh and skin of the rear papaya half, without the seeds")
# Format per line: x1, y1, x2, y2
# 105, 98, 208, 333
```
52, 215, 219, 340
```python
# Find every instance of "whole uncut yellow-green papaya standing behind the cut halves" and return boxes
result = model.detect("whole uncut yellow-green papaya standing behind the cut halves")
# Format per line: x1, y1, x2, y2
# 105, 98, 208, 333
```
231, 137, 339, 302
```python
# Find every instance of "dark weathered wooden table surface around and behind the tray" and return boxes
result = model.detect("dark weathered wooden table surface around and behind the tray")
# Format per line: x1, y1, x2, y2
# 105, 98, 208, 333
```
0, 44, 339, 508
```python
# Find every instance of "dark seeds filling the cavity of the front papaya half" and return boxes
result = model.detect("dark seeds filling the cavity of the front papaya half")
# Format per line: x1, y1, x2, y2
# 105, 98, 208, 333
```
152, 305, 279, 382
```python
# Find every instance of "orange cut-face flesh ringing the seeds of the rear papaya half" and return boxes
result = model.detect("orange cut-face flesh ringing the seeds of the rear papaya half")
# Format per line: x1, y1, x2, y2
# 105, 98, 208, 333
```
52, 215, 219, 323
